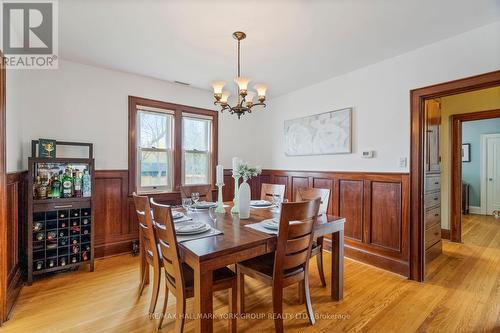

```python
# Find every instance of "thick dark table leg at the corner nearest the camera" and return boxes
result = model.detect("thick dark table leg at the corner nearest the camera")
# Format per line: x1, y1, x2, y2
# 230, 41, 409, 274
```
194, 267, 214, 333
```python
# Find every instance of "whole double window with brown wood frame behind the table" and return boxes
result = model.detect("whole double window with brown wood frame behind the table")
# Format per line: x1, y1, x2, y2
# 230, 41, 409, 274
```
129, 96, 218, 194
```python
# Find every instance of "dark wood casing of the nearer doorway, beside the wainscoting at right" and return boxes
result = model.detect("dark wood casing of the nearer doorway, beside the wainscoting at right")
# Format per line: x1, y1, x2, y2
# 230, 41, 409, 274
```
410, 71, 500, 281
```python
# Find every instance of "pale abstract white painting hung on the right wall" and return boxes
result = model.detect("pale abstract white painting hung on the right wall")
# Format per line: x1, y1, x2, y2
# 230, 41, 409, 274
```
285, 108, 352, 156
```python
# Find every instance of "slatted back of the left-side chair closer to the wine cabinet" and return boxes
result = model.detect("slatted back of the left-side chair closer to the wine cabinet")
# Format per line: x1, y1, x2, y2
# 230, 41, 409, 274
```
133, 193, 159, 263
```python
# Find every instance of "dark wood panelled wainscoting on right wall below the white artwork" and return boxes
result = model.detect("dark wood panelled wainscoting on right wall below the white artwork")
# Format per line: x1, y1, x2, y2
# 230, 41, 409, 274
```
224, 170, 410, 277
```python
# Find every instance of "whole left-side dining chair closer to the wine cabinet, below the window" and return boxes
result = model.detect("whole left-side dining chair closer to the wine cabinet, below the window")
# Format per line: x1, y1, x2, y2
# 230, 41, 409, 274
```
133, 192, 161, 314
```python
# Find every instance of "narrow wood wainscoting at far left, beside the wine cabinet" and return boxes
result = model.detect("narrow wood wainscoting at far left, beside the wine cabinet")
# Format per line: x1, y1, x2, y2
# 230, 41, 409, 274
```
6, 171, 28, 318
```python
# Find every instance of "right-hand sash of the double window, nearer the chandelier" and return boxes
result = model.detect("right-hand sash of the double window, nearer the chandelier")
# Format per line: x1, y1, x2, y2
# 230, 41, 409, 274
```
182, 115, 212, 185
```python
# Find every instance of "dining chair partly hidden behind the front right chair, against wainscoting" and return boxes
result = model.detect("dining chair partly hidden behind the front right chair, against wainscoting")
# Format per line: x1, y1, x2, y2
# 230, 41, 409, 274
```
293, 187, 330, 287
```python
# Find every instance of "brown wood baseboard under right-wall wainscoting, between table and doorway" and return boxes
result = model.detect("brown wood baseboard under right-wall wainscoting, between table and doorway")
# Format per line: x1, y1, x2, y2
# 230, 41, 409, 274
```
323, 238, 410, 277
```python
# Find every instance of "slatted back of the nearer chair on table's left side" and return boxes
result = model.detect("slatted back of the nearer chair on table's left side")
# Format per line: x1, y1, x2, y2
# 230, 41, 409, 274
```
151, 200, 184, 292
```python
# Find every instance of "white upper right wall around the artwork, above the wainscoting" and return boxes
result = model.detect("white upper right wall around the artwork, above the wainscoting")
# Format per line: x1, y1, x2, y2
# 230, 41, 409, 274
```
253, 22, 500, 172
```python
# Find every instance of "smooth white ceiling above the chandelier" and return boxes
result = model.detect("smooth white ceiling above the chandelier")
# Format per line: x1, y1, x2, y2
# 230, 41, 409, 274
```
59, 0, 500, 96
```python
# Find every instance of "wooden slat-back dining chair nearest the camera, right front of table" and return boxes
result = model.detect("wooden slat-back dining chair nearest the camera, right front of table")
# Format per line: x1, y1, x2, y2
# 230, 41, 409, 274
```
236, 198, 320, 333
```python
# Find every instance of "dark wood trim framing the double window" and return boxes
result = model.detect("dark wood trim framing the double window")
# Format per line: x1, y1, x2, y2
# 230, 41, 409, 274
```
128, 96, 219, 195
